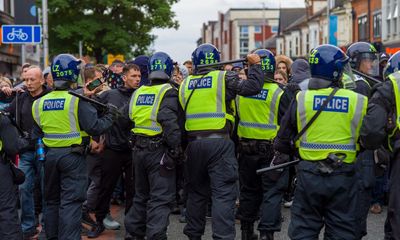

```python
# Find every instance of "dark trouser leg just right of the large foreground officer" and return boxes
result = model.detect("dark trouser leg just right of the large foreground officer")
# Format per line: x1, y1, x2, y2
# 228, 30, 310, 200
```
355, 150, 375, 239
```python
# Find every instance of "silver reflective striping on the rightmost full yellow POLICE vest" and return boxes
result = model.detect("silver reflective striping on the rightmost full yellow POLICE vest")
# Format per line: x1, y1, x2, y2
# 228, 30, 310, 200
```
297, 91, 365, 150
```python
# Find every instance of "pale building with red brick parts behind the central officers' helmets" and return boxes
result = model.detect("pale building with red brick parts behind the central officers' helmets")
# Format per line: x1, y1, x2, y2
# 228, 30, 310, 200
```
199, 8, 280, 61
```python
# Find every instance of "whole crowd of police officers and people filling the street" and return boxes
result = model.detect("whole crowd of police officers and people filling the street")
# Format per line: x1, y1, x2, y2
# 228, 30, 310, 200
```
0, 42, 400, 240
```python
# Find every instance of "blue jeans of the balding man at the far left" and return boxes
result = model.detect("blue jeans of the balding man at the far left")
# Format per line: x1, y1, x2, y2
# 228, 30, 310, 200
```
18, 151, 44, 233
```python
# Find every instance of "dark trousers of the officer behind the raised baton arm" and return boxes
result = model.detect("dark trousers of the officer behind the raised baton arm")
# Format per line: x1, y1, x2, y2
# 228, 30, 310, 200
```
237, 144, 289, 232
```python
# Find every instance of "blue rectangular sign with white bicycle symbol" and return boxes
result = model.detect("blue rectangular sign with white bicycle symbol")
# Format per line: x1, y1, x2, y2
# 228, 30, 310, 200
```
1, 25, 42, 44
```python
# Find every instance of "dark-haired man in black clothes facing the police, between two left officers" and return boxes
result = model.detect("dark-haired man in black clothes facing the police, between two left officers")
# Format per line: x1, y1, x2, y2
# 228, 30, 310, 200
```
88, 64, 141, 238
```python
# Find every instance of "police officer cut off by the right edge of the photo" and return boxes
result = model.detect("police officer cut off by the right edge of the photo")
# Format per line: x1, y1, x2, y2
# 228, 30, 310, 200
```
361, 52, 400, 240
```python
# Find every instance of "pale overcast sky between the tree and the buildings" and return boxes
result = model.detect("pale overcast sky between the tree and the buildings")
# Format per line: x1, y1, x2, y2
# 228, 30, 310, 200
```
152, 0, 304, 63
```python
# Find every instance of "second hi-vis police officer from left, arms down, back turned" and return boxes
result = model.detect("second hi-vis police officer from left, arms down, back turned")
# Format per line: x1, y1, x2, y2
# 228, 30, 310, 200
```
125, 52, 182, 240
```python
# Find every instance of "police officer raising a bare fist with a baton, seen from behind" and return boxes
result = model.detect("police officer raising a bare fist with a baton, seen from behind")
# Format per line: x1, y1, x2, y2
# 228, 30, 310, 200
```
179, 44, 264, 239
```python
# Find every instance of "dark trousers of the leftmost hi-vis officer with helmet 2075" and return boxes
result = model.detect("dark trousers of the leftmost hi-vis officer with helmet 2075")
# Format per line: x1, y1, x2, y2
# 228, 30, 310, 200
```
44, 148, 87, 240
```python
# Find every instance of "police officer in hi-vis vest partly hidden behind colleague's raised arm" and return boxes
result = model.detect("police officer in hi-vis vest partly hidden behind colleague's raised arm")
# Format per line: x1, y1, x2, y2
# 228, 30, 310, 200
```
236, 49, 288, 240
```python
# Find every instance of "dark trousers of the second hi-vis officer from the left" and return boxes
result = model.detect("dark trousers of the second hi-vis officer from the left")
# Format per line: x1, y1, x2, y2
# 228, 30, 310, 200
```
125, 145, 176, 240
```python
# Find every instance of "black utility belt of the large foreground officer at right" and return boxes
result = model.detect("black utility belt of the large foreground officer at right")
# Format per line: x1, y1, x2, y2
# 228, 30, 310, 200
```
300, 153, 355, 176
